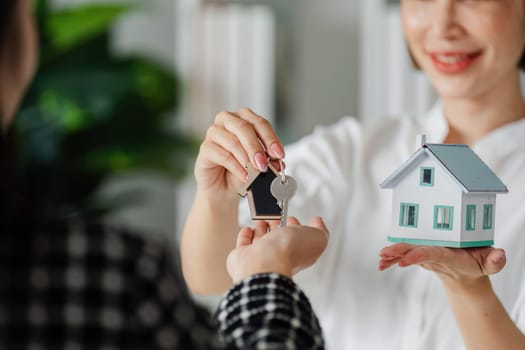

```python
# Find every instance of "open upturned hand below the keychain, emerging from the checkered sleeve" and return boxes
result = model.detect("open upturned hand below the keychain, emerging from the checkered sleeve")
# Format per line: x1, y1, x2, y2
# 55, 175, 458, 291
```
226, 217, 328, 283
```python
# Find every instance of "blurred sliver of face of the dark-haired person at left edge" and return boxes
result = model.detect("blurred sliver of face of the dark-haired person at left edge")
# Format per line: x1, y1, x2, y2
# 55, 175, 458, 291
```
0, 0, 38, 128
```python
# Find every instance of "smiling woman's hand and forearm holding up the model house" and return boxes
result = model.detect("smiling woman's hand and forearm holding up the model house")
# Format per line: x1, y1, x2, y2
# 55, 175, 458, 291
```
379, 243, 525, 350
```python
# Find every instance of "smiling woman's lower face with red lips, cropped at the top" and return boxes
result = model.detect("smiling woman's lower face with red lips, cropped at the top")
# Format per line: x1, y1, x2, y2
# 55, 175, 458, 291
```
401, 0, 525, 98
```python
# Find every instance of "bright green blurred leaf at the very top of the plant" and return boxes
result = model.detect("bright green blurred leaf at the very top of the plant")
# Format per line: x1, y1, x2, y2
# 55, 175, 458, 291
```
46, 5, 131, 51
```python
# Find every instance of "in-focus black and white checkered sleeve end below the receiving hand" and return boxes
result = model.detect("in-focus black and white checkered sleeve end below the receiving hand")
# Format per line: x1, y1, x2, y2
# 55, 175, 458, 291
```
217, 273, 324, 350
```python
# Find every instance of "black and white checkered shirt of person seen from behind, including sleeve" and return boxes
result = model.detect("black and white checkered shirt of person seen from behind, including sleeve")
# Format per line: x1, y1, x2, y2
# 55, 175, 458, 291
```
0, 218, 323, 350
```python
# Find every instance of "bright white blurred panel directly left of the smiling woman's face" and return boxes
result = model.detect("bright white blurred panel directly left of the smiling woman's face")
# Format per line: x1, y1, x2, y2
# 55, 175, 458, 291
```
359, 0, 436, 120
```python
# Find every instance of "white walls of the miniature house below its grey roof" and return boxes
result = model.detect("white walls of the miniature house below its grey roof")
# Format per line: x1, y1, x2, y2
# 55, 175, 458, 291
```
390, 153, 496, 246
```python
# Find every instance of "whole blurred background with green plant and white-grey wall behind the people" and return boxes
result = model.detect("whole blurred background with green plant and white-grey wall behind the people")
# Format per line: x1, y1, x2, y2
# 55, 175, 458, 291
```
16, 0, 435, 249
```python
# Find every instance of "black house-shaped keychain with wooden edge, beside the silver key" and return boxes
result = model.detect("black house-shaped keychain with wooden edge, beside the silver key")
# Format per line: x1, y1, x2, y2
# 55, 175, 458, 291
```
239, 163, 281, 220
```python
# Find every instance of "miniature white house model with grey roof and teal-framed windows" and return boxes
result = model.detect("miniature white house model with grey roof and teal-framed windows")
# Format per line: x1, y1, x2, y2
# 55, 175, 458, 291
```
381, 135, 508, 247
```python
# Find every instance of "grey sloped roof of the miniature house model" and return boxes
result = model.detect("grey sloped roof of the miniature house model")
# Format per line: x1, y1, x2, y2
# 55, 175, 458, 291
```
381, 143, 508, 193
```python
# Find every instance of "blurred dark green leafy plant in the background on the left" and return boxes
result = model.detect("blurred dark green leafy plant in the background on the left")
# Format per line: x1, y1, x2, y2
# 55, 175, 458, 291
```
15, 0, 196, 216
